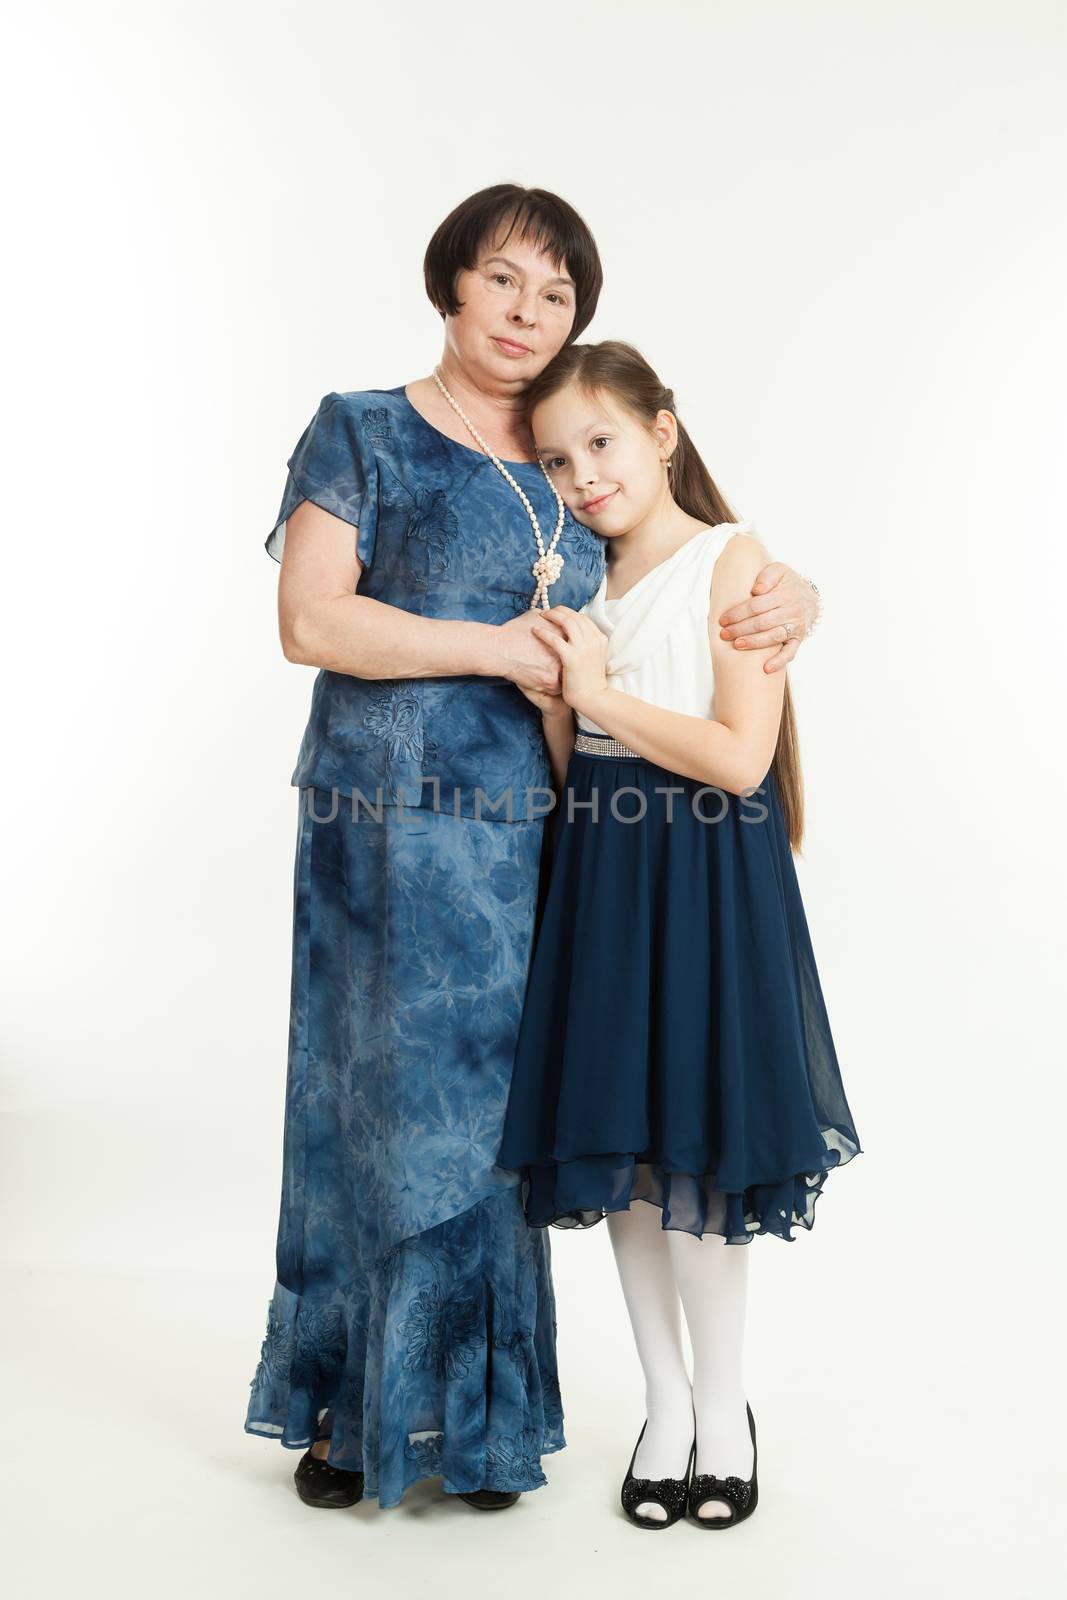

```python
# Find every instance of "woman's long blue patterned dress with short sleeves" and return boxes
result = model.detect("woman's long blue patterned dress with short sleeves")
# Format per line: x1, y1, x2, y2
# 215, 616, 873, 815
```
245, 387, 605, 1506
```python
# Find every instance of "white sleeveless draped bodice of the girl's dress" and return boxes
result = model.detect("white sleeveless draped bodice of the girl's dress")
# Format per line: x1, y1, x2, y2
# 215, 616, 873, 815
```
577, 522, 757, 733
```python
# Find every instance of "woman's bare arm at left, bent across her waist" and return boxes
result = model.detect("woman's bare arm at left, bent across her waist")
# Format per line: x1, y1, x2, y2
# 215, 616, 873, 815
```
278, 501, 560, 693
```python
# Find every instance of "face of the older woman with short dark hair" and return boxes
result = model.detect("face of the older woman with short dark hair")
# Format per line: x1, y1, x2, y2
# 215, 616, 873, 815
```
445, 235, 574, 392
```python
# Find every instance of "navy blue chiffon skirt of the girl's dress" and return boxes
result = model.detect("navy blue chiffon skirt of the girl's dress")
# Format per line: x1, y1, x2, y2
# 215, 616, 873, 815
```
498, 736, 861, 1245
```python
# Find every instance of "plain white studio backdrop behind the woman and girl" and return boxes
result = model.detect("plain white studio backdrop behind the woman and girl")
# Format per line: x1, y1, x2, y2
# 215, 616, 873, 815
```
0, 0, 1067, 1600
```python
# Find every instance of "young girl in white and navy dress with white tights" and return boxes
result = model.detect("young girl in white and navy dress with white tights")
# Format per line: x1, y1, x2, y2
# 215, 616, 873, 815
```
498, 341, 861, 1530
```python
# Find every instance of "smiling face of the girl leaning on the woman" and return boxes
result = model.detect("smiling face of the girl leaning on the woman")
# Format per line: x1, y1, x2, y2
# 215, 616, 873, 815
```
530, 382, 678, 539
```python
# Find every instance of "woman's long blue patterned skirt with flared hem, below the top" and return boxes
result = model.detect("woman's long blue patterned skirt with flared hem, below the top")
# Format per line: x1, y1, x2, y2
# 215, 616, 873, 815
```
245, 789, 565, 1506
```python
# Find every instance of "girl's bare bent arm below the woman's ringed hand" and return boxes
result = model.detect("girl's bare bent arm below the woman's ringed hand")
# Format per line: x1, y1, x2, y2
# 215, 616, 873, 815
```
541, 533, 785, 795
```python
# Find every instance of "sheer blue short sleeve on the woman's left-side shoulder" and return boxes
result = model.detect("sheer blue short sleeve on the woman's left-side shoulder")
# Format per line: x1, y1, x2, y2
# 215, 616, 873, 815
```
264, 394, 378, 566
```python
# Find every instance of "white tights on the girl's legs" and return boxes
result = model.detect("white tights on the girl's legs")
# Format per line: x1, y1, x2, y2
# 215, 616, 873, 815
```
608, 1200, 752, 1520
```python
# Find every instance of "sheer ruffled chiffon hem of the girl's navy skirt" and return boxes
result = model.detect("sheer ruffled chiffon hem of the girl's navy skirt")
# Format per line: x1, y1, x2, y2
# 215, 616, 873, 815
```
522, 1128, 862, 1245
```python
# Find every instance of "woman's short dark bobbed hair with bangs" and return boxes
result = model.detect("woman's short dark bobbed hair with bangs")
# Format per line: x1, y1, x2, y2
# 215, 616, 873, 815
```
422, 184, 603, 344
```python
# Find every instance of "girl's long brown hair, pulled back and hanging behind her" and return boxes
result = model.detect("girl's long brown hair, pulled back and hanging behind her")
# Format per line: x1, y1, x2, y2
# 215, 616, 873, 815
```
523, 339, 805, 854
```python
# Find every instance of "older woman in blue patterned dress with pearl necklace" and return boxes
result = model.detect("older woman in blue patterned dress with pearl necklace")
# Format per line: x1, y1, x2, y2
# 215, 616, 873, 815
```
245, 184, 816, 1509
